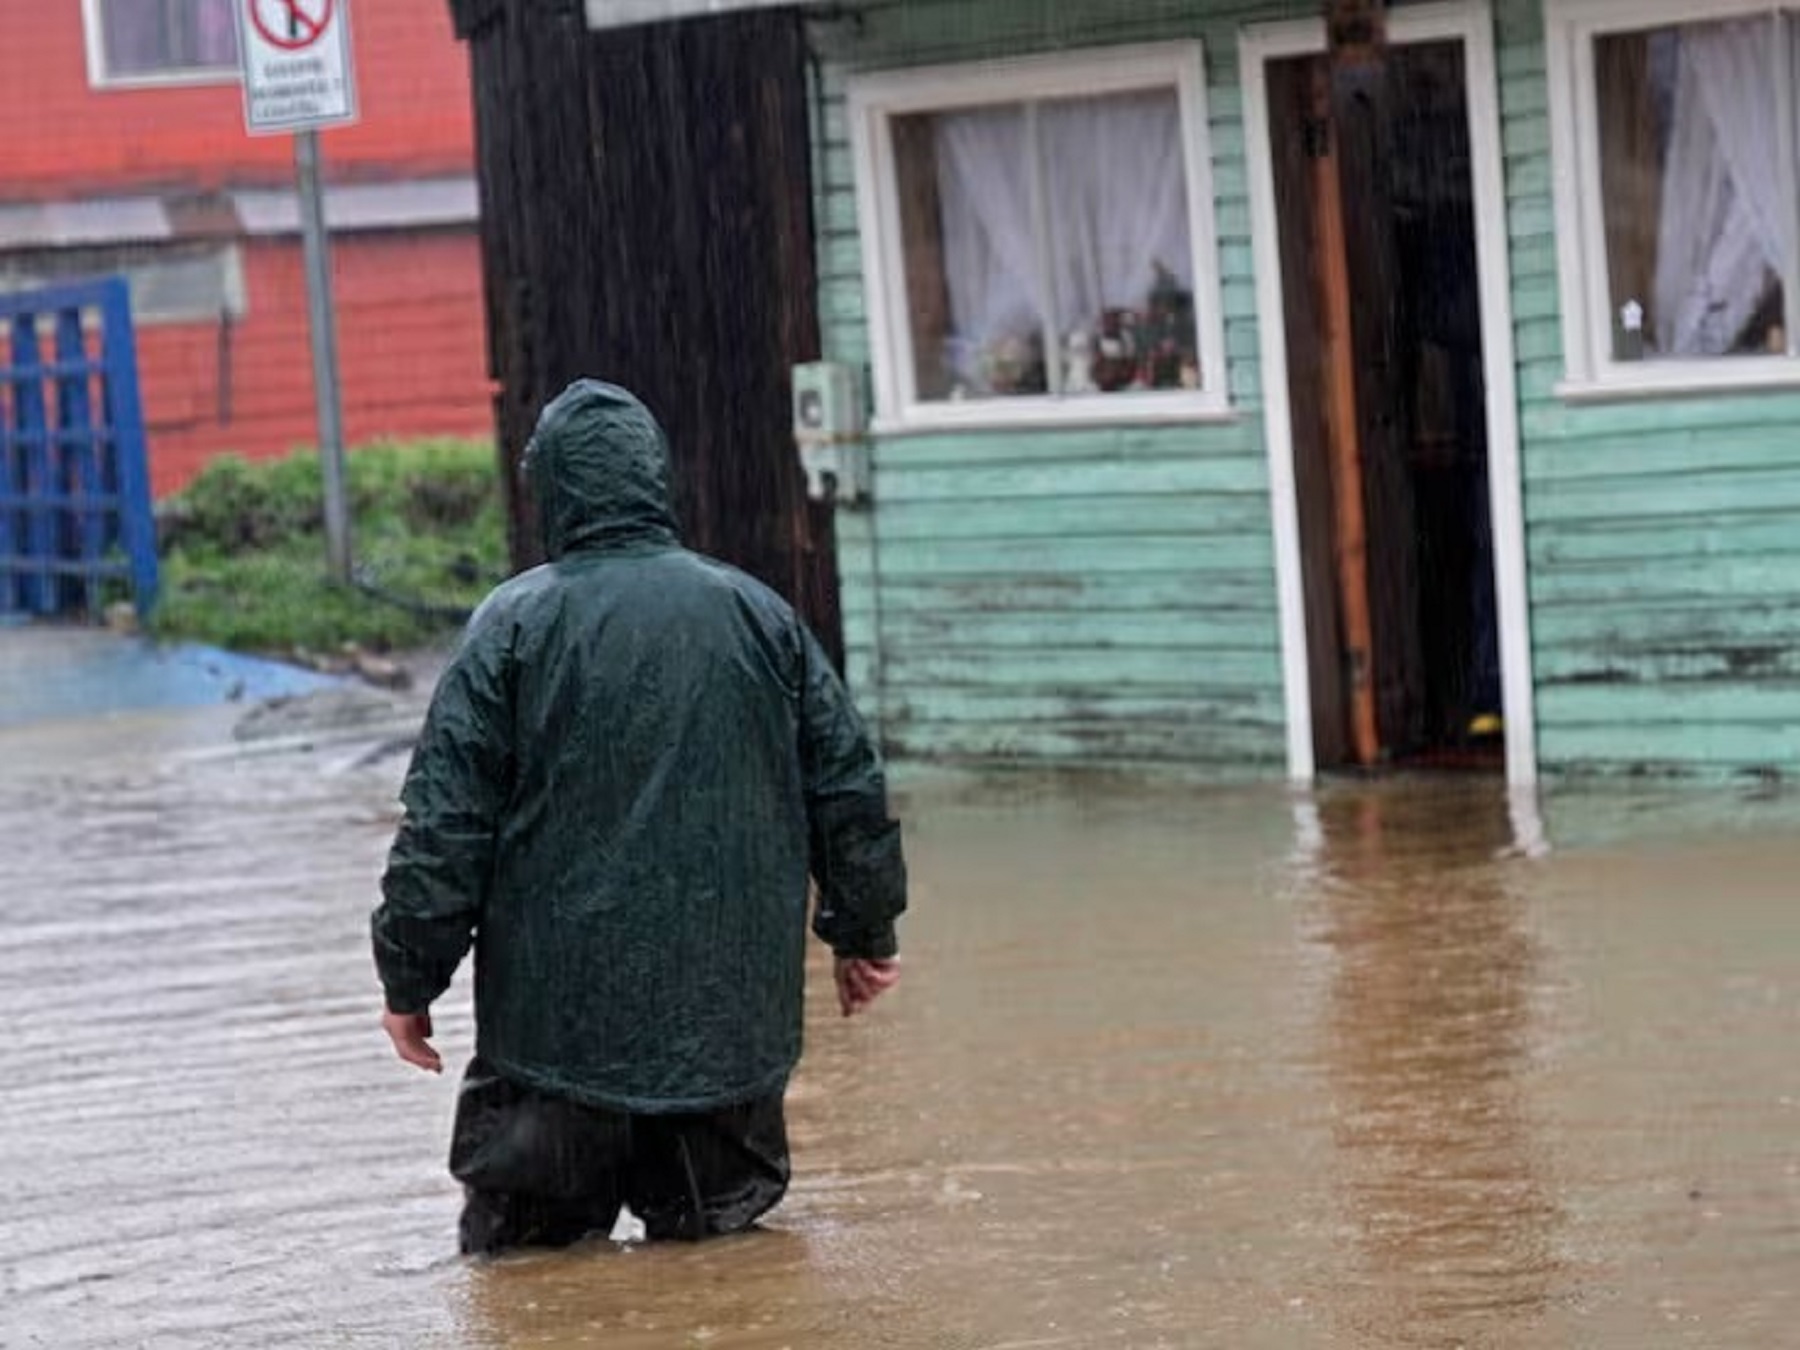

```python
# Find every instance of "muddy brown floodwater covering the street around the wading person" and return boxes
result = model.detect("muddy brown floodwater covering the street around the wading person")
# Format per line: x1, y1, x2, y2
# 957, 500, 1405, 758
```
0, 712, 1800, 1350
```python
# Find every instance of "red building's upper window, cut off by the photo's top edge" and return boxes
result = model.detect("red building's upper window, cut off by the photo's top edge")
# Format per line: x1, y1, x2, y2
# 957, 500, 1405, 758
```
86, 0, 238, 85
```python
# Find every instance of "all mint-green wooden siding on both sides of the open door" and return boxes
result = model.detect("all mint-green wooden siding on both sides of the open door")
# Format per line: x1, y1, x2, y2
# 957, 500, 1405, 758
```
815, 0, 1800, 778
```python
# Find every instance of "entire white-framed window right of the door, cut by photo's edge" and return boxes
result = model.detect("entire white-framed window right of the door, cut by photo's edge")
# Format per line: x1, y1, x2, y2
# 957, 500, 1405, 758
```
1552, 2, 1800, 391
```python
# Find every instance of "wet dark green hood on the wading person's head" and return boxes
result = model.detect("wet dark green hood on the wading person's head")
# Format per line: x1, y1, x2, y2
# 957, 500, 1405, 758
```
524, 380, 677, 558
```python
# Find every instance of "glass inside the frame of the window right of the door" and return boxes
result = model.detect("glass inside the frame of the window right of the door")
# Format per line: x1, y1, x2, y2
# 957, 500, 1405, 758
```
1595, 16, 1793, 360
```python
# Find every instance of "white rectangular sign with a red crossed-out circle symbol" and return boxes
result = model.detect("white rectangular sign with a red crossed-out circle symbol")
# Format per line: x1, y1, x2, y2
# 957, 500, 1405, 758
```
238, 0, 356, 135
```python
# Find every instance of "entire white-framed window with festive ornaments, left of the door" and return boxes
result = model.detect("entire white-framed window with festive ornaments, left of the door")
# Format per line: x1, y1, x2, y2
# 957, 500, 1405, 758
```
851, 45, 1226, 425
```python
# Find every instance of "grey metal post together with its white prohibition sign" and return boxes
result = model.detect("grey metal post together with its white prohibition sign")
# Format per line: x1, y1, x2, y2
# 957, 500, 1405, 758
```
238, 0, 356, 583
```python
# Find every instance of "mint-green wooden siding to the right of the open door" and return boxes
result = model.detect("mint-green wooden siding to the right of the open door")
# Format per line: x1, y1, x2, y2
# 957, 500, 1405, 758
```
1498, 0, 1800, 778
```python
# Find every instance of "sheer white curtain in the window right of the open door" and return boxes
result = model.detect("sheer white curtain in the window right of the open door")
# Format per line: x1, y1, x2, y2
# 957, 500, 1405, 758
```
1656, 16, 1800, 356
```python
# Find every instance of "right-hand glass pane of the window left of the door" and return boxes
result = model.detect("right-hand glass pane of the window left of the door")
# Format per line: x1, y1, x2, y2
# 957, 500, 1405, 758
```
1039, 90, 1201, 394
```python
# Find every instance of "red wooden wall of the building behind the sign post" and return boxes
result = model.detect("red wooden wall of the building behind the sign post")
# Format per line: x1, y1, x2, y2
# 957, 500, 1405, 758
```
0, 0, 493, 495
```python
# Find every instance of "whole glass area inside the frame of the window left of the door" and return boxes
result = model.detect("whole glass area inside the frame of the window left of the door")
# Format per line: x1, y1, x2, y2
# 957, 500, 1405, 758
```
891, 88, 1199, 401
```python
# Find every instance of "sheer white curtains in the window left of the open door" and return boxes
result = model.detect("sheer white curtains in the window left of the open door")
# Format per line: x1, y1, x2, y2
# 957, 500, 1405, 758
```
936, 90, 1193, 382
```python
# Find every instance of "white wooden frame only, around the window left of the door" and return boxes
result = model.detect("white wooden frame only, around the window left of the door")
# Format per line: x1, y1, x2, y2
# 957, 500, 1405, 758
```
848, 41, 1235, 432
